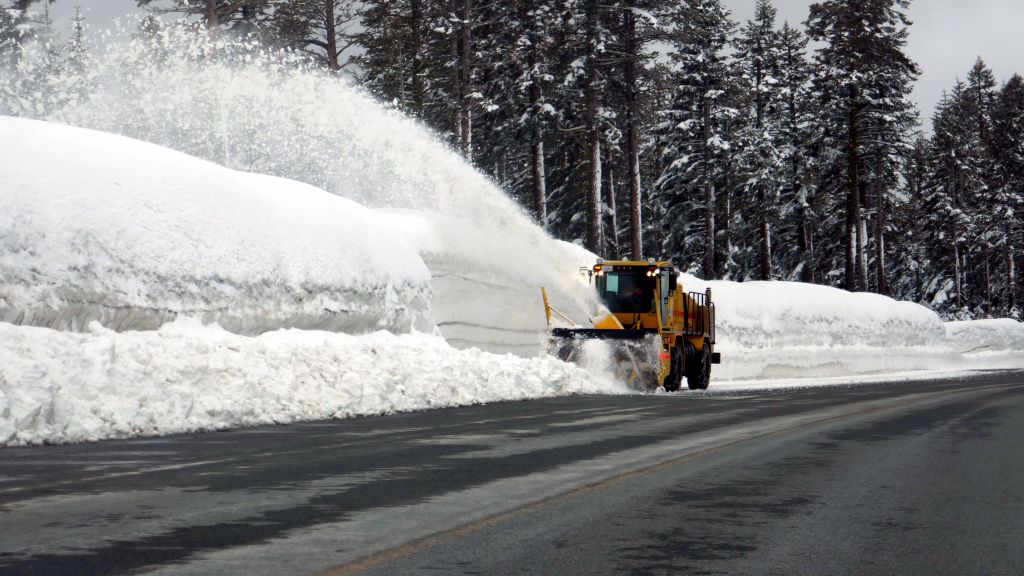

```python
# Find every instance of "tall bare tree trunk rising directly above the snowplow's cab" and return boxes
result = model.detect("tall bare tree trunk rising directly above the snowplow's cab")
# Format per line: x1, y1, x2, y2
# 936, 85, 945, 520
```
624, 0, 643, 260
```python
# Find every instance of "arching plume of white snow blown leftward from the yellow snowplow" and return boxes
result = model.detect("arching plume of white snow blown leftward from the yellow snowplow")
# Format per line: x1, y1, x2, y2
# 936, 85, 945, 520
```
0, 26, 593, 355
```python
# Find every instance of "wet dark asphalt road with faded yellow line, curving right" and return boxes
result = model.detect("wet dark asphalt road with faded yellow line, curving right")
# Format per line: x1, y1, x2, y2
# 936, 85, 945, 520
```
0, 372, 1024, 576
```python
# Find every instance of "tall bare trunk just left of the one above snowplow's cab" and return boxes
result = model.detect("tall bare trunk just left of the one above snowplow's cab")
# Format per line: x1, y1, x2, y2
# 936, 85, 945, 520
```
586, 0, 604, 253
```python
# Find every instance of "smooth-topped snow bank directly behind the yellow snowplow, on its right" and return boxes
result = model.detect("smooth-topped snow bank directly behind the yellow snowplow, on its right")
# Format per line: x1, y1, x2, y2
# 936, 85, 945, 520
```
680, 275, 959, 380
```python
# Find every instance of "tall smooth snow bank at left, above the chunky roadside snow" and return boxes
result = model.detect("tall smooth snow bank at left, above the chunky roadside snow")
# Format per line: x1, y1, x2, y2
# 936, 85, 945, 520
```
0, 117, 432, 334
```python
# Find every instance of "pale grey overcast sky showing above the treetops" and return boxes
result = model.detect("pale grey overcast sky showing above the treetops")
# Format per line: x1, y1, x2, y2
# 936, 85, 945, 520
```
52, 0, 1024, 125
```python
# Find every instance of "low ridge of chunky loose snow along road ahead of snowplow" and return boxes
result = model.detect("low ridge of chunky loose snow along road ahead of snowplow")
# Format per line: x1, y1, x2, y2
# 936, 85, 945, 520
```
0, 320, 626, 445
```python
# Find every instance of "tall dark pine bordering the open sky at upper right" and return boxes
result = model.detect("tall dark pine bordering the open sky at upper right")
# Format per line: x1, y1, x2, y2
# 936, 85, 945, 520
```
807, 0, 920, 291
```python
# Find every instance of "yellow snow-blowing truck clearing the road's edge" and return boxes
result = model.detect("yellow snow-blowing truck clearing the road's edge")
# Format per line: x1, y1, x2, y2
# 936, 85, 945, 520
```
541, 258, 721, 392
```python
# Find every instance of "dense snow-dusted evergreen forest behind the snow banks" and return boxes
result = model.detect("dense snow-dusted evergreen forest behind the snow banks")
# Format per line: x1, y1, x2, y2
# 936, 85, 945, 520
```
0, 0, 1024, 319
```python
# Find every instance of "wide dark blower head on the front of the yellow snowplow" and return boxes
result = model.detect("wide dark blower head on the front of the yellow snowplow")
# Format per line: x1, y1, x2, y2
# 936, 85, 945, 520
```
549, 328, 662, 390
